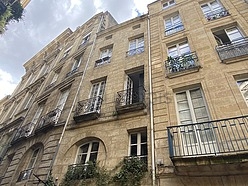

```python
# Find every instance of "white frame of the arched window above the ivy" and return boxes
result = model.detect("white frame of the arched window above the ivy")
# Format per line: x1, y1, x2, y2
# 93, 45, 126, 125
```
75, 140, 100, 165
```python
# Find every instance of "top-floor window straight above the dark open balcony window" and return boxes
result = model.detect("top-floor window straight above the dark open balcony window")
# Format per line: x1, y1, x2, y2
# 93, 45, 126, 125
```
127, 36, 144, 56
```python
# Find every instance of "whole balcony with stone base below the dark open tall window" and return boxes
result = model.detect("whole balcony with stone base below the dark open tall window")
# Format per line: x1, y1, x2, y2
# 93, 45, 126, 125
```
115, 86, 146, 114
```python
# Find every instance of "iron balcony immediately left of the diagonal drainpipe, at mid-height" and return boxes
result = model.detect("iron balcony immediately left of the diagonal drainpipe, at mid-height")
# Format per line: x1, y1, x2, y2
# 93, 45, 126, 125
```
35, 108, 61, 133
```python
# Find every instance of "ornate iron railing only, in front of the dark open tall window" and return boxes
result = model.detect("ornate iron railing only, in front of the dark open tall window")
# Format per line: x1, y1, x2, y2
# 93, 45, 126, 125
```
116, 86, 146, 107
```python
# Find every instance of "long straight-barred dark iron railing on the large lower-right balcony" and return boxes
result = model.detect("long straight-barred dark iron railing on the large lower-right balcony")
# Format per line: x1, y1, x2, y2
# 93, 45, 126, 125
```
167, 116, 248, 158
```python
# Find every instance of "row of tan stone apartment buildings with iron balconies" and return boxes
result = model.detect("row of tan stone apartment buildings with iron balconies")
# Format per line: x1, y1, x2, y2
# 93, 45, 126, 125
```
0, 0, 248, 186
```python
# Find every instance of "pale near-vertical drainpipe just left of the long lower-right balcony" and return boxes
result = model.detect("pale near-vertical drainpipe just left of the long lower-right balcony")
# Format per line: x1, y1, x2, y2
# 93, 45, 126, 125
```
147, 13, 156, 186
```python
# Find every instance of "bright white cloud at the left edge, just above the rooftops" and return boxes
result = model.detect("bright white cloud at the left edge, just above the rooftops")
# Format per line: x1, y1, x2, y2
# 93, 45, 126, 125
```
0, 69, 17, 99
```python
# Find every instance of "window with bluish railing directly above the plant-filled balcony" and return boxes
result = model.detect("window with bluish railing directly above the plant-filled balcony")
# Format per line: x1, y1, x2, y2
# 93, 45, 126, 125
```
165, 14, 184, 35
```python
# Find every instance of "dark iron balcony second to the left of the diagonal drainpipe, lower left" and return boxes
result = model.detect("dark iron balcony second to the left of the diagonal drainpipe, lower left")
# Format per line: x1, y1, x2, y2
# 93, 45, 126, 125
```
11, 123, 34, 145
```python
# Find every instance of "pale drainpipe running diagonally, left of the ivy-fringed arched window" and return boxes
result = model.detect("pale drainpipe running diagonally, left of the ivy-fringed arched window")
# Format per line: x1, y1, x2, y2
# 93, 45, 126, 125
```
46, 14, 103, 180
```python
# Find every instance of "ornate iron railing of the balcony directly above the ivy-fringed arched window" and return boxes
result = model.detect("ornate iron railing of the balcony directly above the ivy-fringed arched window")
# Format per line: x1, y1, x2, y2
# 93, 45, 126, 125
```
74, 96, 102, 117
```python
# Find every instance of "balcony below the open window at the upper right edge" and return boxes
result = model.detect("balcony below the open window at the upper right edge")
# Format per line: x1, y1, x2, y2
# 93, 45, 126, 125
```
216, 37, 248, 63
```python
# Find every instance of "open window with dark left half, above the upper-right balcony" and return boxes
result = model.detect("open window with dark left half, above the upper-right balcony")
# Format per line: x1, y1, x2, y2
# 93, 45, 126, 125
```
213, 27, 244, 45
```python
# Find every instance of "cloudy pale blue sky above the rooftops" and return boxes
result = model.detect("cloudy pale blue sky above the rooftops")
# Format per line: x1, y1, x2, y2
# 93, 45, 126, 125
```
0, 0, 154, 99
